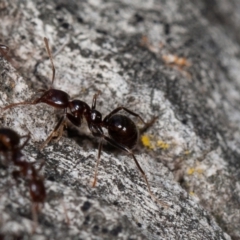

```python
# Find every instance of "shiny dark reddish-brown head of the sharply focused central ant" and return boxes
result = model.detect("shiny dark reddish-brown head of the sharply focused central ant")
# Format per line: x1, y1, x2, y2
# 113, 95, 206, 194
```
35, 89, 70, 109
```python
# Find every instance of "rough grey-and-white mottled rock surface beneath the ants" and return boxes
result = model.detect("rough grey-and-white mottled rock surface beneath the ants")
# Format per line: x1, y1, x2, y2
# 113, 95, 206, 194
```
0, 0, 240, 239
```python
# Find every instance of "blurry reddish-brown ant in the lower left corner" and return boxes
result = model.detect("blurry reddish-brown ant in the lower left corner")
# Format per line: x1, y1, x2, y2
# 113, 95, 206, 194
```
0, 128, 46, 231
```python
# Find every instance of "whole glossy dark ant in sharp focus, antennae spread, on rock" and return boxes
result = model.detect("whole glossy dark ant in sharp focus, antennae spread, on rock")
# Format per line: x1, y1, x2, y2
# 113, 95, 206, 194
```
0, 38, 166, 205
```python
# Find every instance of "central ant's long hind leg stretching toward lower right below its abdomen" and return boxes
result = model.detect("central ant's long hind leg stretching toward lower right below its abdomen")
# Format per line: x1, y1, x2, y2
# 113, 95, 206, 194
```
102, 135, 169, 207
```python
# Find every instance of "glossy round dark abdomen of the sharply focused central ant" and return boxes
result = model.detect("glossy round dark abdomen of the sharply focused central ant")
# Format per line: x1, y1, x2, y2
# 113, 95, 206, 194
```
107, 114, 139, 149
